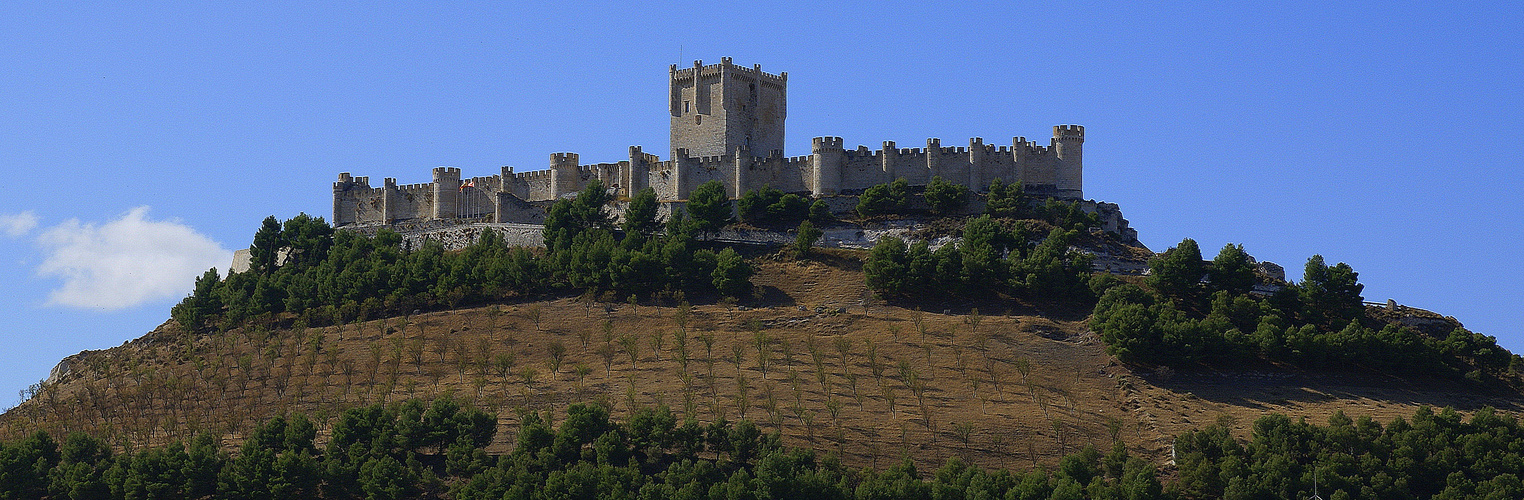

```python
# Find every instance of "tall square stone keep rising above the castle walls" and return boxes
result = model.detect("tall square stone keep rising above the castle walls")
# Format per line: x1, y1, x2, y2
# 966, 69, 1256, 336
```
669, 58, 788, 159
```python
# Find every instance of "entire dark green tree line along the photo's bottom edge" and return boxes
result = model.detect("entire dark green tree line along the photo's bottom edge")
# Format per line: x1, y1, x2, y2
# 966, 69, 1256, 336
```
14, 396, 1524, 500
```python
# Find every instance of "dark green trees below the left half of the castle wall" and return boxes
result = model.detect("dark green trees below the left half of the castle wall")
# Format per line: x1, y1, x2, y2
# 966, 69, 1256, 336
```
171, 181, 751, 329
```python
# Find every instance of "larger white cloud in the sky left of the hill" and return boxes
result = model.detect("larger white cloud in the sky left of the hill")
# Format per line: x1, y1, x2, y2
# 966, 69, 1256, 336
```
37, 206, 233, 311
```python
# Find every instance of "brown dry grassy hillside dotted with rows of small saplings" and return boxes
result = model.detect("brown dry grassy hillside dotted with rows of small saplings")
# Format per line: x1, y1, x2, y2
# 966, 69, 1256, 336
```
0, 252, 1524, 466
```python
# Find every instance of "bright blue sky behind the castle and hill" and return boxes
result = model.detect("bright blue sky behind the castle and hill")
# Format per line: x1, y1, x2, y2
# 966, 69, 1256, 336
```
0, 2, 1524, 405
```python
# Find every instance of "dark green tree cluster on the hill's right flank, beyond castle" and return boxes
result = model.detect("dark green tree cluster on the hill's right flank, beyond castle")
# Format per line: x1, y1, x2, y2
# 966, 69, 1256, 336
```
1091, 239, 1518, 378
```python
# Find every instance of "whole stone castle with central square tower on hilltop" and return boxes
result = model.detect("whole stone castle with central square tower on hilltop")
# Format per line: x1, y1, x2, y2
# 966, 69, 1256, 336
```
332, 58, 1085, 226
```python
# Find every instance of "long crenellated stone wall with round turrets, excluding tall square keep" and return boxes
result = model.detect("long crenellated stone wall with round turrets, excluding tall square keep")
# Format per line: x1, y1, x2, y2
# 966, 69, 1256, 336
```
334, 125, 1084, 226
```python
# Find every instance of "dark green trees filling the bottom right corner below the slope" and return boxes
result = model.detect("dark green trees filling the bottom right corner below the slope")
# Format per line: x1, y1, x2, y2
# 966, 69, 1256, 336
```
1172, 407, 1524, 500
